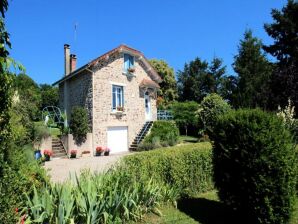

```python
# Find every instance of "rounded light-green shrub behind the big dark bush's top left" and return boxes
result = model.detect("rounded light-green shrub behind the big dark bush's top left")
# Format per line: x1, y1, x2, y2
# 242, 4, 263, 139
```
197, 93, 231, 130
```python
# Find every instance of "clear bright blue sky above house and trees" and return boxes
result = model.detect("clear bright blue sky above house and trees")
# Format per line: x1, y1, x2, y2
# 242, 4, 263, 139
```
6, 0, 287, 84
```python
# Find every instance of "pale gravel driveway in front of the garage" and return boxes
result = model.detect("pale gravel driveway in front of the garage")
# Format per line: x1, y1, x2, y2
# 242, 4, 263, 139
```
44, 153, 131, 183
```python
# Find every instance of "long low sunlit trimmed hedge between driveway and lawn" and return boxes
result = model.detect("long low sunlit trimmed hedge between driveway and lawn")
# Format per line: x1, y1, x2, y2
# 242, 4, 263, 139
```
118, 142, 213, 195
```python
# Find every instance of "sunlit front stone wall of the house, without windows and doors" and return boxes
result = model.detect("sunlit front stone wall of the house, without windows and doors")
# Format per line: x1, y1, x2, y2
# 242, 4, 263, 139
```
93, 53, 157, 150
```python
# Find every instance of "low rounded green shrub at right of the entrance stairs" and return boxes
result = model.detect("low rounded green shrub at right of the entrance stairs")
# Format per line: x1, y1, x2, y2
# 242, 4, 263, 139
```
139, 121, 179, 150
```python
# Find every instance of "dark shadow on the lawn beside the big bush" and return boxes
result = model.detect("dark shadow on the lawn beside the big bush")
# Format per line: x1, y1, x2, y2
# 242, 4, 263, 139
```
178, 198, 245, 224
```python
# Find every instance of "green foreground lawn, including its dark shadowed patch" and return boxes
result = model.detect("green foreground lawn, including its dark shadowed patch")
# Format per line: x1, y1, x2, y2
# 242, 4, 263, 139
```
141, 191, 298, 224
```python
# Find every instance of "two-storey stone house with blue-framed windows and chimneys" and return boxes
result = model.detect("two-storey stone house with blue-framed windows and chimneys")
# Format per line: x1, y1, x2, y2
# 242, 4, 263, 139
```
53, 44, 162, 155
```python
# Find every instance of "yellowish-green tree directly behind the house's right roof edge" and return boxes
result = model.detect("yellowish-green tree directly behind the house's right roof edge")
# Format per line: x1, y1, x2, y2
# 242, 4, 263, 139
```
150, 59, 178, 106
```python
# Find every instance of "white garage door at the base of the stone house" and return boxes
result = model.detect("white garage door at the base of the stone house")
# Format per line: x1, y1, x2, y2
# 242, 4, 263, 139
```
108, 127, 128, 153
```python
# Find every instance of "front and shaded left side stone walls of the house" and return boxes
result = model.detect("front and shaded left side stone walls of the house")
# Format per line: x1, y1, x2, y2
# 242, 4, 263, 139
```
59, 52, 157, 154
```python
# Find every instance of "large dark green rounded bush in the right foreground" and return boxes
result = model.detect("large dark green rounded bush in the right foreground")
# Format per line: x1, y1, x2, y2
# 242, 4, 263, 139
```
210, 109, 297, 223
